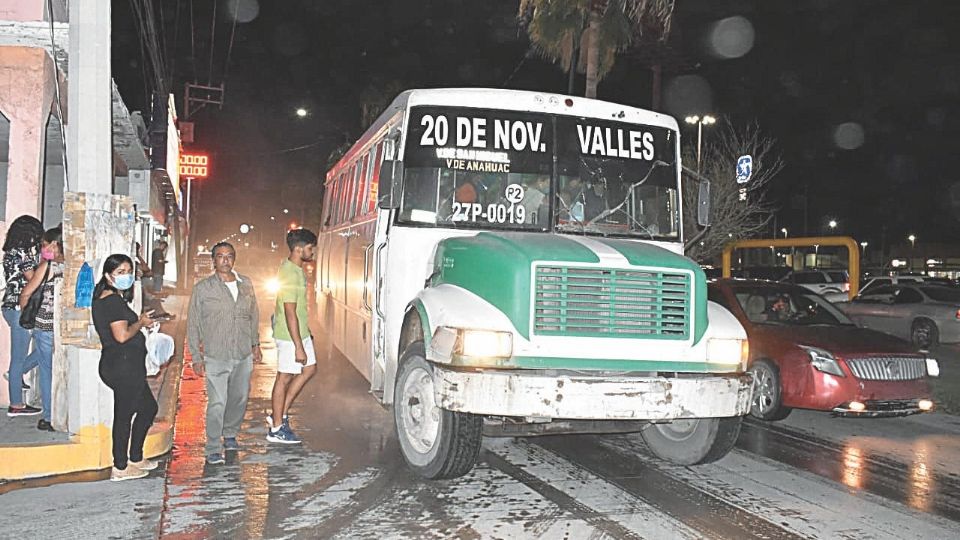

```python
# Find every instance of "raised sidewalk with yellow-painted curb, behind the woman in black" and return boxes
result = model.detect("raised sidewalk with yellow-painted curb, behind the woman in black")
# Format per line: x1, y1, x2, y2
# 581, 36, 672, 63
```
0, 295, 189, 484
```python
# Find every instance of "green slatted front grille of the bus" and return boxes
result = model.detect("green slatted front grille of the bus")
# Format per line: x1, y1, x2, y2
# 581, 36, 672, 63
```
533, 265, 692, 340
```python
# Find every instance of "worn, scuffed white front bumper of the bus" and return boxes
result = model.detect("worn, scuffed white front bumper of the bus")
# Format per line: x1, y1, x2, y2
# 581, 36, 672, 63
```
434, 366, 753, 421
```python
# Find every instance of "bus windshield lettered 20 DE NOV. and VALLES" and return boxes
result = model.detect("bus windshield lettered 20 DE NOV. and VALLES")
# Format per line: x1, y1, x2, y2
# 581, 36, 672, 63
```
398, 107, 680, 240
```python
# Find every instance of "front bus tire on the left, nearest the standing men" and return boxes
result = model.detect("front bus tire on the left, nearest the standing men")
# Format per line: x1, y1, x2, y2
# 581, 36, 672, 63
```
393, 341, 483, 480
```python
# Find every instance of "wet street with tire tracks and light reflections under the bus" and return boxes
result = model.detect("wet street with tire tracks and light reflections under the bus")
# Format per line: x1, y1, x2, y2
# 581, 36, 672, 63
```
152, 298, 960, 539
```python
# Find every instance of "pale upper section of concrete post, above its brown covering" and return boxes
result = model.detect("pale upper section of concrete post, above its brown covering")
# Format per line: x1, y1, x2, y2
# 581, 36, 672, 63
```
67, 2, 113, 193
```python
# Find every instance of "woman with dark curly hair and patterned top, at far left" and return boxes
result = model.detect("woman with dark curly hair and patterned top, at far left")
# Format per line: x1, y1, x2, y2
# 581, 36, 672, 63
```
3, 216, 43, 416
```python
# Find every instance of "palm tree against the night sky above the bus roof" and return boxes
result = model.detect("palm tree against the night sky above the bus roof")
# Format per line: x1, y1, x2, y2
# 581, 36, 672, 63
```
518, 0, 674, 98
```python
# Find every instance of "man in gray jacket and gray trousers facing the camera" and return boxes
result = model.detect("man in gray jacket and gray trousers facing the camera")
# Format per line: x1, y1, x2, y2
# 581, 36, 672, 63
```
187, 242, 261, 465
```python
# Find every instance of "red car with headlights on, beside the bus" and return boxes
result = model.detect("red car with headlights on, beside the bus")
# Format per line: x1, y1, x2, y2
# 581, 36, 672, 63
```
709, 279, 940, 420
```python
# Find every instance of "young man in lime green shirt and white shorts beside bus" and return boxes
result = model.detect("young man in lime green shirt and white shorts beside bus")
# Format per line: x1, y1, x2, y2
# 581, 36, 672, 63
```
267, 229, 317, 444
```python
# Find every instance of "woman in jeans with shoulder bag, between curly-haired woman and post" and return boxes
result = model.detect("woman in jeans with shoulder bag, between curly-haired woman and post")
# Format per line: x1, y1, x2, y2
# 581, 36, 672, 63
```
20, 227, 63, 431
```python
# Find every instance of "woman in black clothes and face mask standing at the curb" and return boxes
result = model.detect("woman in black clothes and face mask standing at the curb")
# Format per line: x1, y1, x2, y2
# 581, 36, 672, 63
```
93, 253, 157, 480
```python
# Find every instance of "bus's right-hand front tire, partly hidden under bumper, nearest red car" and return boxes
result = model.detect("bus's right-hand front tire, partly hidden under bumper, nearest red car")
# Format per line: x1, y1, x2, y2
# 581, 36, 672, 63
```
640, 416, 743, 465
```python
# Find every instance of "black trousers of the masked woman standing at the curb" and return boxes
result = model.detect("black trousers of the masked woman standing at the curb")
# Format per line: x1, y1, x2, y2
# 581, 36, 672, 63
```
100, 361, 157, 470
